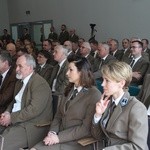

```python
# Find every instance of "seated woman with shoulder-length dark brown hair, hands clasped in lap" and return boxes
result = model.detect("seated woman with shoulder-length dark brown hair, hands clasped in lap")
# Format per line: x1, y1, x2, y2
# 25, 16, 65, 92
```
31, 58, 101, 150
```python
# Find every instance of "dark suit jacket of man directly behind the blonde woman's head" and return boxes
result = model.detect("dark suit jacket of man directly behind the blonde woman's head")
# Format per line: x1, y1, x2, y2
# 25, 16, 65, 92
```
93, 55, 117, 80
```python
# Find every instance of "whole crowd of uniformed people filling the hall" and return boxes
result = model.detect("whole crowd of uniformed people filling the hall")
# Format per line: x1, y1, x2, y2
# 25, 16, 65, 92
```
0, 24, 150, 150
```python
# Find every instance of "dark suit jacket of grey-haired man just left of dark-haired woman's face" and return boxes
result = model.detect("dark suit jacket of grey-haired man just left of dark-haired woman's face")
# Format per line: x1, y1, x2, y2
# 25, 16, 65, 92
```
49, 60, 69, 95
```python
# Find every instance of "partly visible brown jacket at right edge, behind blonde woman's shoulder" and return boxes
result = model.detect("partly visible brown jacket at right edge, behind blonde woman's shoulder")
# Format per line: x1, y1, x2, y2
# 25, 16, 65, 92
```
137, 74, 150, 108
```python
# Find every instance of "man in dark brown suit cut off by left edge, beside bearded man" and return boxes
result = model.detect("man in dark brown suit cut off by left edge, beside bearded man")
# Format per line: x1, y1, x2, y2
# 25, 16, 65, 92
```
0, 51, 17, 114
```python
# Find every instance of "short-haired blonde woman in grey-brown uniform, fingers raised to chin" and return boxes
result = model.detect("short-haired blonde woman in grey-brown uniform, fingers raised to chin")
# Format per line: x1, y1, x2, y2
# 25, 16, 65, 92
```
91, 62, 148, 150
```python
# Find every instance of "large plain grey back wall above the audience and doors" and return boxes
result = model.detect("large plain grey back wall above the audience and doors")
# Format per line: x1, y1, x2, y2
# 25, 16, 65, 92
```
8, 0, 150, 41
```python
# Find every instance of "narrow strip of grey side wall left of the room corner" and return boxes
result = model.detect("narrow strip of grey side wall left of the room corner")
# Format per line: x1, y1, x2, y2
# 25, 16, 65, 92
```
0, 0, 10, 35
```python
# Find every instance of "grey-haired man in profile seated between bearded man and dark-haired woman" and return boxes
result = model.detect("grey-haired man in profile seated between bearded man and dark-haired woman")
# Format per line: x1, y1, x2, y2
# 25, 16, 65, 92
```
49, 45, 68, 114
